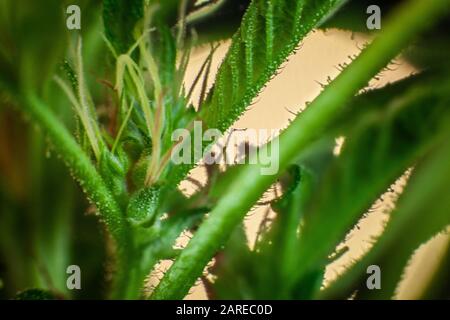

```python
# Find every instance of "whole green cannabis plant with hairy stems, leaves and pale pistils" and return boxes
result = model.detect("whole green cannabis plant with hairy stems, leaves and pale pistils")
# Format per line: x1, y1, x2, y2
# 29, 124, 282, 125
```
0, 0, 450, 299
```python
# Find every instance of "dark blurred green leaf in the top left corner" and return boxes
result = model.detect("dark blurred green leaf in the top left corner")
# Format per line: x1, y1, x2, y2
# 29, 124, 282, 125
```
0, 0, 67, 90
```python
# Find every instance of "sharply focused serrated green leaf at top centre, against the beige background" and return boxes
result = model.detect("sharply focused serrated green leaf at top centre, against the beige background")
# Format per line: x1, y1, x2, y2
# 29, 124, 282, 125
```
201, 0, 343, 131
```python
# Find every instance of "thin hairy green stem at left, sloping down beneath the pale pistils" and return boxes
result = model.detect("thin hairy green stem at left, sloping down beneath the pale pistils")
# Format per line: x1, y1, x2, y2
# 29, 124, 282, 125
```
23, 94, 132, 297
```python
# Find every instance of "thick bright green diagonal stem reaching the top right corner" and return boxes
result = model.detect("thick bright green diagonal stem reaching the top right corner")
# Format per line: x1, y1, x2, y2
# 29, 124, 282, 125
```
151, 0, 450, 299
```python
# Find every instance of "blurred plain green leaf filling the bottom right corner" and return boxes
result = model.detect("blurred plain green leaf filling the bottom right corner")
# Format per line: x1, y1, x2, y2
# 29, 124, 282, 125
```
321, 128, 450, 299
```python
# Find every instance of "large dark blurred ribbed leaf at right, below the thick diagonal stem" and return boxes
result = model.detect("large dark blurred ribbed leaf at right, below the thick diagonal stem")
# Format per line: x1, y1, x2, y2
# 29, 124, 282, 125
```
296, 75, 448, 290
